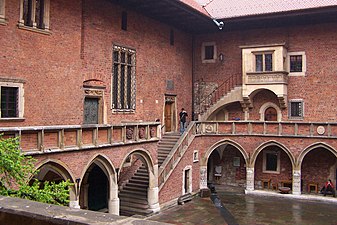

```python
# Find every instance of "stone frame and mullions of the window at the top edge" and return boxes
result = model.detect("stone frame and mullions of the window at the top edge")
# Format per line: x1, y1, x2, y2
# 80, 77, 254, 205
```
18, 0, 51, 34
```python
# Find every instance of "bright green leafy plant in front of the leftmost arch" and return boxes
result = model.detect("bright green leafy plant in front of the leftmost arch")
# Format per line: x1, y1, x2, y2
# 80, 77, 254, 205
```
0, 134, 73, 205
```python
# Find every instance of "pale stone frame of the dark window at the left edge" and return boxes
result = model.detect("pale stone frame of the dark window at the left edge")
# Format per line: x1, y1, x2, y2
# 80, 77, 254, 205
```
0, 78, 25, 121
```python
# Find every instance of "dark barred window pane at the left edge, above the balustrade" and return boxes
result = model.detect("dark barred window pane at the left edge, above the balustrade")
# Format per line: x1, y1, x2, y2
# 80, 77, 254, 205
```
1, 87, 18, 118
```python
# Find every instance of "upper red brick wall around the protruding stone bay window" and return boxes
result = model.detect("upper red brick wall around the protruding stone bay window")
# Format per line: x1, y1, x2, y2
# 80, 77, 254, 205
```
195, 23, 337, 121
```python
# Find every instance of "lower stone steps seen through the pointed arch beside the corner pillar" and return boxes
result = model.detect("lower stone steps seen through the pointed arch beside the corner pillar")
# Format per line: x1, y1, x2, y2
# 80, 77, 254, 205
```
119, 165, 152, 216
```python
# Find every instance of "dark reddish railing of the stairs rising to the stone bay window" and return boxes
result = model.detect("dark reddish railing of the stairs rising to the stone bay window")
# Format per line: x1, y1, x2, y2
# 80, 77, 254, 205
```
197, 75, 239, 115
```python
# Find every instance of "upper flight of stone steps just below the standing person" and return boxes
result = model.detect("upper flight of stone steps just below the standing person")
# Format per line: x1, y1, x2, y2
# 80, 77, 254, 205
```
158, 133, 181, 167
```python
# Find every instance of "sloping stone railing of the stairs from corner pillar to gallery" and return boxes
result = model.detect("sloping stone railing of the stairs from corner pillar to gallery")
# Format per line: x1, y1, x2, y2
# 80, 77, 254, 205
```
158, 121, 196, 190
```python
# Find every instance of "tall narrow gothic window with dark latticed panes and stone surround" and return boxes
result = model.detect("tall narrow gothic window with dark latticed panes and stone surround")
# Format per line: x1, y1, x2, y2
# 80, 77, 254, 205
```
111, 45, 136, 111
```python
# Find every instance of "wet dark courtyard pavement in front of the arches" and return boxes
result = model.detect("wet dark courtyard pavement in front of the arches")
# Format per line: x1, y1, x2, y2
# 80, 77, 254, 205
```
147, 185, 337, 225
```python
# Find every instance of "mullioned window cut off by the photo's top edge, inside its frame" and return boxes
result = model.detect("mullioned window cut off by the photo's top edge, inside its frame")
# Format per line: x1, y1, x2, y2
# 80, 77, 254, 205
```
19, 0, 50, 30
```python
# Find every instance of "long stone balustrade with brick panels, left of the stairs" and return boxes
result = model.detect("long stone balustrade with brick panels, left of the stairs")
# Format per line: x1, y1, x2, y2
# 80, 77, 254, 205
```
0, 122, 161, 155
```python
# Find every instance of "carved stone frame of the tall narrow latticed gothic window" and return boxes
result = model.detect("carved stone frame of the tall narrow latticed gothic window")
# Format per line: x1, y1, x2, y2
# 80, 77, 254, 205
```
110, 44, 136, 113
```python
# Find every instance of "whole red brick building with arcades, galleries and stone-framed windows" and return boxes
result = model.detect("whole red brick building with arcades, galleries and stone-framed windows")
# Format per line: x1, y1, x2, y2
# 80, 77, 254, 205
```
0, 0, 337, 215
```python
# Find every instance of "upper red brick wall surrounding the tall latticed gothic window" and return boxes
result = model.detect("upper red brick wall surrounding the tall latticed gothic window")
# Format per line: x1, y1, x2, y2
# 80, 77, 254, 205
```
0, 0, 192, 126
